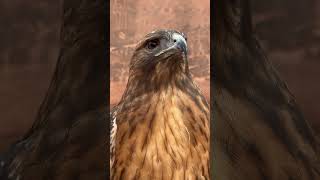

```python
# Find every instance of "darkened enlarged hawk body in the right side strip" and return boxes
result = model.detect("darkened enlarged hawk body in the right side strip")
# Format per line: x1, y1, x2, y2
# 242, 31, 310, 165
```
211, 0, 320, 180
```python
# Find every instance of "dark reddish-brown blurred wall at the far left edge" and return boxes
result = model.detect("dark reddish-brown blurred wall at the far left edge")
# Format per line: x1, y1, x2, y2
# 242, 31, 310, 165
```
0, 0, 62, 153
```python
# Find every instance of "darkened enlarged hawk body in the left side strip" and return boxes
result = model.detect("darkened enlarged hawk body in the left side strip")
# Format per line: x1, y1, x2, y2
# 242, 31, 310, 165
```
0, 0, 109, 179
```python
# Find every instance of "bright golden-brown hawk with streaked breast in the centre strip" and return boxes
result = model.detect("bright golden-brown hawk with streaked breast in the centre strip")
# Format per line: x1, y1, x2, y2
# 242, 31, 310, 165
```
110, 30, 210, 179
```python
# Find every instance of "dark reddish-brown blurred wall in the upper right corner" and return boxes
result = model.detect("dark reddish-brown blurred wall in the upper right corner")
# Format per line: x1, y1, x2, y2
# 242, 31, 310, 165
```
251, 0, 320, 134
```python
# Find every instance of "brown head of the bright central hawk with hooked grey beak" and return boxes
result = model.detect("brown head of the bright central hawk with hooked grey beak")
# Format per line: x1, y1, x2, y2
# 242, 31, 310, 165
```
129, 30, 189, 84
